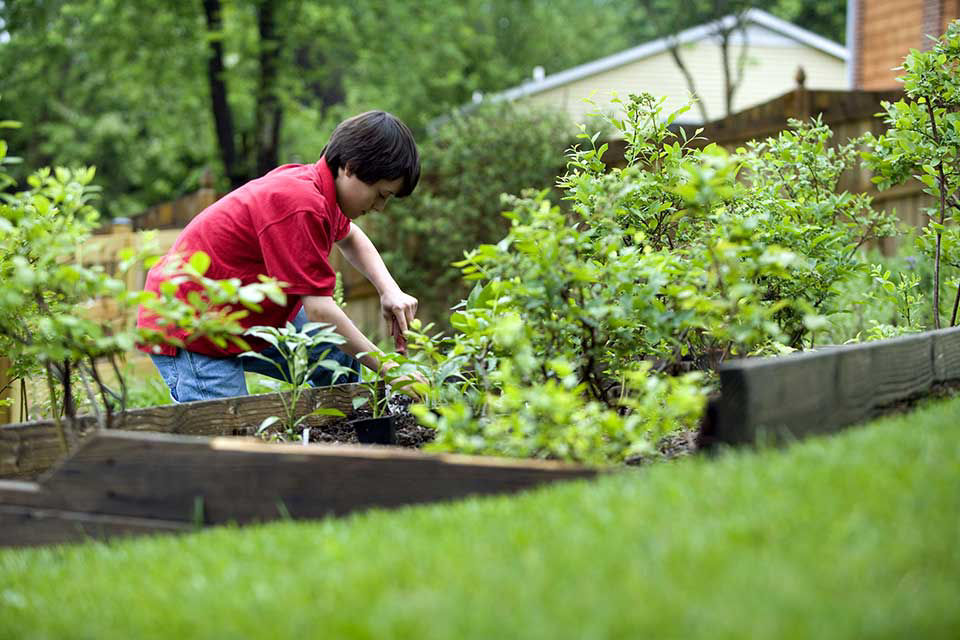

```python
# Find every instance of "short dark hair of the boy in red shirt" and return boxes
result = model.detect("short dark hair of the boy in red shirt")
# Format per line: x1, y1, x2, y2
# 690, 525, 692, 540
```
321, 111, 420, 198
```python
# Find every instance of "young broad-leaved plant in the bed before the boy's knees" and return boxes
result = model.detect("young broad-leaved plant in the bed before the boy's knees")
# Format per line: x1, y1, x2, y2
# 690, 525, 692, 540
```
243, 322, 349, 442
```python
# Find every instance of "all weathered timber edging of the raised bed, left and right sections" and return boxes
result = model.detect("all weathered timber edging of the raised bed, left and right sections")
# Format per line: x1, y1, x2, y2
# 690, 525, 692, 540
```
0, 328, 960, 545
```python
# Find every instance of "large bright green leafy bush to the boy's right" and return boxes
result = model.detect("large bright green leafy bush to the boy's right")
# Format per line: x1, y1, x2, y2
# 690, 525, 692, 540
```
404, 94, 892, 462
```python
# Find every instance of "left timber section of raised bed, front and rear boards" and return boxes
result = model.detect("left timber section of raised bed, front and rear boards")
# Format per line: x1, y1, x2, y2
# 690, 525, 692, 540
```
0, 385, 597, 546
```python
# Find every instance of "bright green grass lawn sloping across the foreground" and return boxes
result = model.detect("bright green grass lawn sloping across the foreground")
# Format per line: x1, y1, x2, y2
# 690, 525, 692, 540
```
0, 398, 960, 640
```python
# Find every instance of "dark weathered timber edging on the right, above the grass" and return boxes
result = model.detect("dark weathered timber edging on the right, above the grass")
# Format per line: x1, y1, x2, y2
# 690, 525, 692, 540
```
705, 327, 960, 444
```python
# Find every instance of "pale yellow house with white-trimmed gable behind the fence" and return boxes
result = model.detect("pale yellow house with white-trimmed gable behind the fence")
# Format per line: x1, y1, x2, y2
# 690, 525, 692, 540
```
491, 8, 848, 124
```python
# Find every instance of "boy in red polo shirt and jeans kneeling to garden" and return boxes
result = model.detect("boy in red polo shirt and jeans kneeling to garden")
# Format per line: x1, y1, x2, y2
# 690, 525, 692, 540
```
137, 111, 420, 402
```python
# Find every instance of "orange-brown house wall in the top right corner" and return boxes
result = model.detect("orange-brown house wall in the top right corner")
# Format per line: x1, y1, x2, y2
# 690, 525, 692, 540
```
847, 0, 960, 91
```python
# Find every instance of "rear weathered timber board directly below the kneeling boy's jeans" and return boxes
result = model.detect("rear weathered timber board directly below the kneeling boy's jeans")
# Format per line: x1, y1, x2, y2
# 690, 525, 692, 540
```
0, 384, 366, 478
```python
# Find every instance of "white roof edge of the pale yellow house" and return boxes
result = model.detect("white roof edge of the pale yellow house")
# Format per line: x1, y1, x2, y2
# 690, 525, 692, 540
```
491, 9, 849, 100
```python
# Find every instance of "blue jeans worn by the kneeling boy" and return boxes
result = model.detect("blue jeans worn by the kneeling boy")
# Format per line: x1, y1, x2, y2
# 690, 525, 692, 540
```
150, 309, 360, 402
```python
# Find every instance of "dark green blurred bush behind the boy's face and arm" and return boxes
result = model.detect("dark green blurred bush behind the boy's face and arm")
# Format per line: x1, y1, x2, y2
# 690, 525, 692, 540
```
370, 103, 575, 321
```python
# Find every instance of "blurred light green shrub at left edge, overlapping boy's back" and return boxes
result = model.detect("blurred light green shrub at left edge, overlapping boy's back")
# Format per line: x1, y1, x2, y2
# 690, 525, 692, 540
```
0, 128, 284, 435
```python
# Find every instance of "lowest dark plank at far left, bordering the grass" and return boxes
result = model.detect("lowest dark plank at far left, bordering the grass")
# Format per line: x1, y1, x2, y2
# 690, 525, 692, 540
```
0, 504, 196, 547
